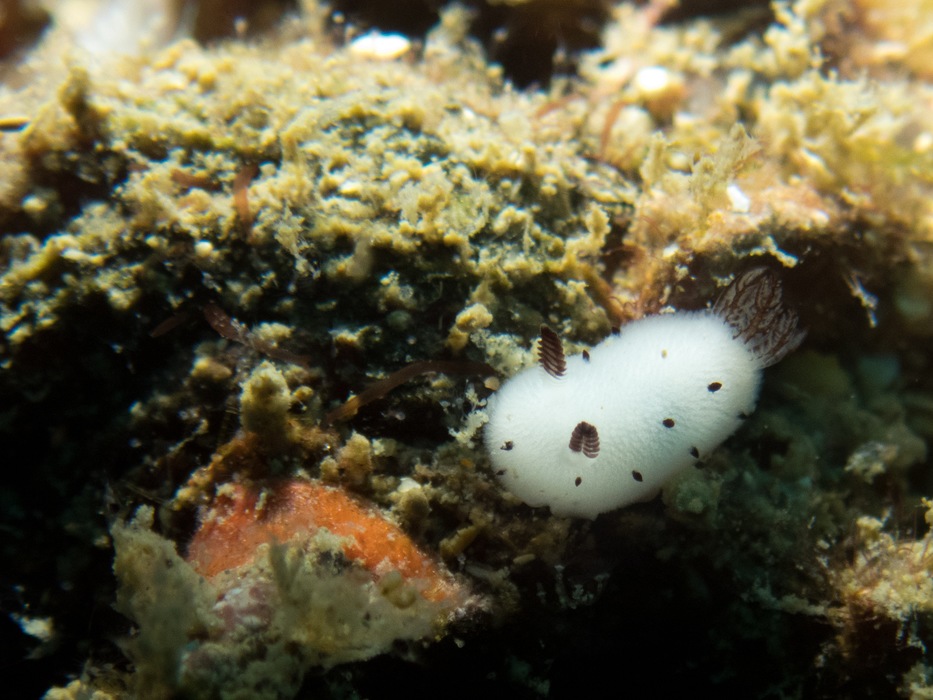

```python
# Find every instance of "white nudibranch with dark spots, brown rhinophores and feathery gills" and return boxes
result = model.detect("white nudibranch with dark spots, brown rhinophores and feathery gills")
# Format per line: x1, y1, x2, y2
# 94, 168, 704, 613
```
485, 268, 804, 518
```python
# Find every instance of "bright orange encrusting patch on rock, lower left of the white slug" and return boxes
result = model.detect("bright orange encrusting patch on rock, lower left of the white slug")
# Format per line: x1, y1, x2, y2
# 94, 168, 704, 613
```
187, 481, 457, 601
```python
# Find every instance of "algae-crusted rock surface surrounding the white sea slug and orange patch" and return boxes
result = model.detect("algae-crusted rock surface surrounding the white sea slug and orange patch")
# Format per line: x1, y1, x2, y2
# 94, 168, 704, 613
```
0, 0, 933, 697
